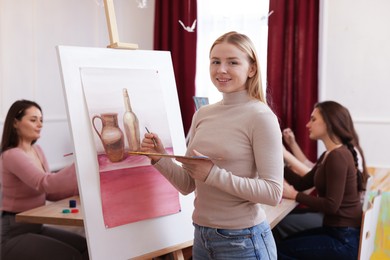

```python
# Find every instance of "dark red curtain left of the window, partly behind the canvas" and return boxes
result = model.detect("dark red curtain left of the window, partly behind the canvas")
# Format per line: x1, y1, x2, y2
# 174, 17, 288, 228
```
154, 0, 197, 134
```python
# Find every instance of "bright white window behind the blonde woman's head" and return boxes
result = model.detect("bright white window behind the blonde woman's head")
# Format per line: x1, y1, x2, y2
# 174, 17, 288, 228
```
195, 0, 269, 103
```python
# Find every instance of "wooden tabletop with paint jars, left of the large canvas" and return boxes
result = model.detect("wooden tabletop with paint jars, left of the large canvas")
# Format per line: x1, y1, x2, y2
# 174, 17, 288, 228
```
15, 196, 84, 226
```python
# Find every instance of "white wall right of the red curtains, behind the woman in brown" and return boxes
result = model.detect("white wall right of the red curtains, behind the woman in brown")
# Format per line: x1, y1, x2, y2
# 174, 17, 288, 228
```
319, 0, 390, 167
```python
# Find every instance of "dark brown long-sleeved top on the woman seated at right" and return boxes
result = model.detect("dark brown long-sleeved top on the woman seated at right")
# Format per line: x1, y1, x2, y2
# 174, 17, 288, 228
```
285, 145, 362, 227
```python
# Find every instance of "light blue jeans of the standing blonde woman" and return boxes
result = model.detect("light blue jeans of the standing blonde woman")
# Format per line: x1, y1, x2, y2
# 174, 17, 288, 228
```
192, 221, 276, 260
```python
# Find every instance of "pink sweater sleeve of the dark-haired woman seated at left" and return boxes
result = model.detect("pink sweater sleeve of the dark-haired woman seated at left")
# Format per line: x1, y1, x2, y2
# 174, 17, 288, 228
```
3, 146, 78, 200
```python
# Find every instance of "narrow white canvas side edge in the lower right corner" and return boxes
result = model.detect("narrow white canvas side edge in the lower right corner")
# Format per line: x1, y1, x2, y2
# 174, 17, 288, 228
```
358, 190, 382, 260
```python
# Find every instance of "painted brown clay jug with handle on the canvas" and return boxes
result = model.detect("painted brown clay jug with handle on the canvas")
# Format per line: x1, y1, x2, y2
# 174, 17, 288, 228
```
92, 113, 125, 162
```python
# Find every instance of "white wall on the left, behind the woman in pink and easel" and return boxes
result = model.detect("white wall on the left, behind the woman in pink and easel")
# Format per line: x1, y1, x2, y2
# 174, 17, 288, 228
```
0, 0, 154, 169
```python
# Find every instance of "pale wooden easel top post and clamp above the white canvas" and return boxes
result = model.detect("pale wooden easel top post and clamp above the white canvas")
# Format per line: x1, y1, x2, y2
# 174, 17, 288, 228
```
104, 0, 138, 50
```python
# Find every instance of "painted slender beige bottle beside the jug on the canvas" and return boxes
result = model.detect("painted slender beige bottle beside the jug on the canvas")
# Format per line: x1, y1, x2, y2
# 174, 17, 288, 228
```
123, 88, 140, 151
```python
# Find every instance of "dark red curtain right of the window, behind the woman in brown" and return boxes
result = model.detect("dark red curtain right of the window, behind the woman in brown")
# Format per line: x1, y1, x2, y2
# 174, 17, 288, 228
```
267, 0, 319, 161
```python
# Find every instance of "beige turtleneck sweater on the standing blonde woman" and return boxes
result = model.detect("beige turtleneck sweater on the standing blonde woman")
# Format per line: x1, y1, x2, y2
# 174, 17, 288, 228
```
155, 91, 283, 229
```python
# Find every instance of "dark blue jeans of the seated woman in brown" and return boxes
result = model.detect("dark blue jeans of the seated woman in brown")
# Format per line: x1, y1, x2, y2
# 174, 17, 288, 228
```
277, 224, 360, 260
